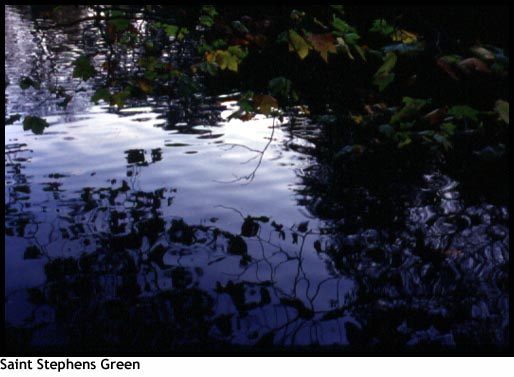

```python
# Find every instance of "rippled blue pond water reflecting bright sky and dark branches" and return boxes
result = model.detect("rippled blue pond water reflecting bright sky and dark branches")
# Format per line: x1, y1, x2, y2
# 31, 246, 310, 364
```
5, 6, 509, 352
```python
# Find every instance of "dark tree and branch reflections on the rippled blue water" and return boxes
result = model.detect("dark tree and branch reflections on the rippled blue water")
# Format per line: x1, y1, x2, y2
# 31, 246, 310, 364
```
6, 112, 508, 351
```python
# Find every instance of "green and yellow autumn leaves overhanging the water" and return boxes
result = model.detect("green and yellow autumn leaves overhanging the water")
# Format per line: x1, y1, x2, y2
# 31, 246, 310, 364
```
10, 5, 509, 164
